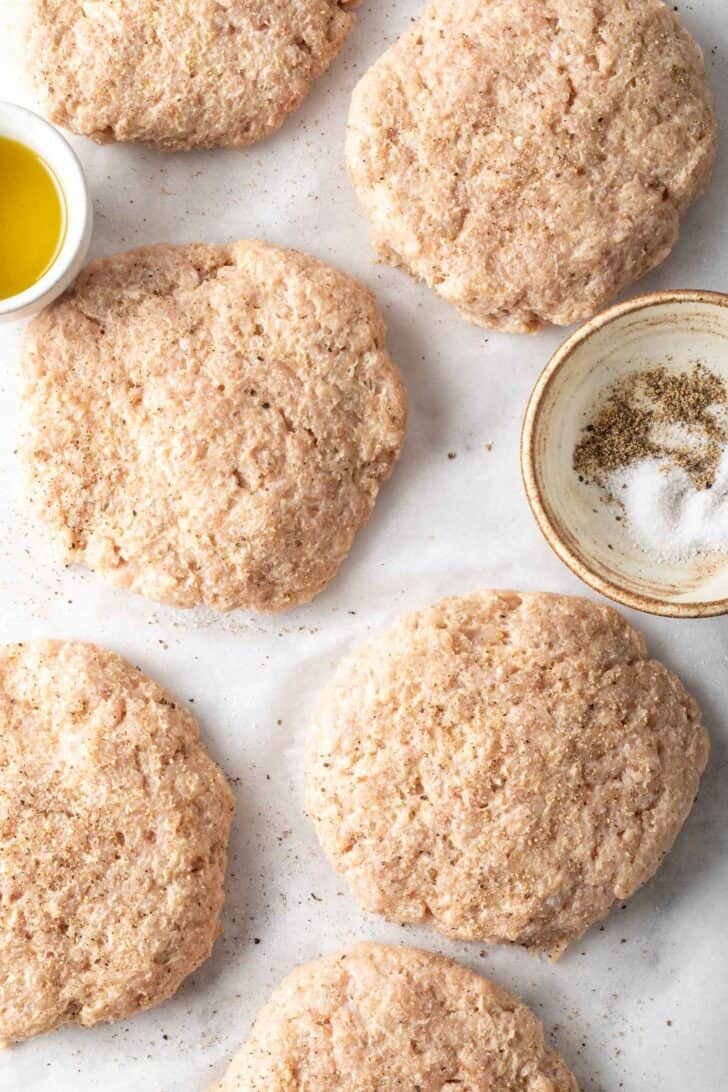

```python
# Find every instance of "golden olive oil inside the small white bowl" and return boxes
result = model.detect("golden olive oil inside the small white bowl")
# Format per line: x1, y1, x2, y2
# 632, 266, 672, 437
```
0, 137, 65, 299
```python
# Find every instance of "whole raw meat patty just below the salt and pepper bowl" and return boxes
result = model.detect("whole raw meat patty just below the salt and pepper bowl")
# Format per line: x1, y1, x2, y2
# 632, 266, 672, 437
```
307, 592, 708, 954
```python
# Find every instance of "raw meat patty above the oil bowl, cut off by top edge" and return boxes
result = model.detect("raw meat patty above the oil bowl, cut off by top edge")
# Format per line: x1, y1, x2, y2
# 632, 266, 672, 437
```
28, 0, 355, 149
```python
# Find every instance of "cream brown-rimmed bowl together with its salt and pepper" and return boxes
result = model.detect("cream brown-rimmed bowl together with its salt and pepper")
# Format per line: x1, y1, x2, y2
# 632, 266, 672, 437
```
521, 290, 728, 617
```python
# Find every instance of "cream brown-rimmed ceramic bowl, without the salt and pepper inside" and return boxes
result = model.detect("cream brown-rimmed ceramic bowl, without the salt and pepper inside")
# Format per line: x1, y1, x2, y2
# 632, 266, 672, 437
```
521, 292, 728, 617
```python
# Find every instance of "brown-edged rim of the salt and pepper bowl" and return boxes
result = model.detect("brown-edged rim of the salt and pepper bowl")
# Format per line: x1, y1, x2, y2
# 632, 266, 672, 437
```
521, 288, 728, 618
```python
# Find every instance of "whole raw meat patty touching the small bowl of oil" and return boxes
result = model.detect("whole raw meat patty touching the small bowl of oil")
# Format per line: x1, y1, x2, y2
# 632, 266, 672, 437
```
22, 241, 406, 612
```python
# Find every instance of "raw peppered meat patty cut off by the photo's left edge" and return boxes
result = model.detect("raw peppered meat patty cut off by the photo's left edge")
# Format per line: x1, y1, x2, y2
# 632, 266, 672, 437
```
0, 641, 232, 1042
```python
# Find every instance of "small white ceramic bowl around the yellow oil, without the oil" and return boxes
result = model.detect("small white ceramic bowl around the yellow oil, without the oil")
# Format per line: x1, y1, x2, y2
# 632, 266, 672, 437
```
0, 102, 94, 322
